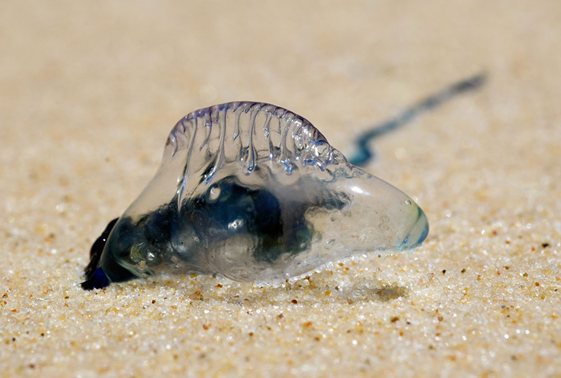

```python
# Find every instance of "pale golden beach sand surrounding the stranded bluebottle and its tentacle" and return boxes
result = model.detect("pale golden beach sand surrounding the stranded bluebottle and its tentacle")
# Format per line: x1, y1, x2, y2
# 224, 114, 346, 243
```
0, 0, 561, 377
